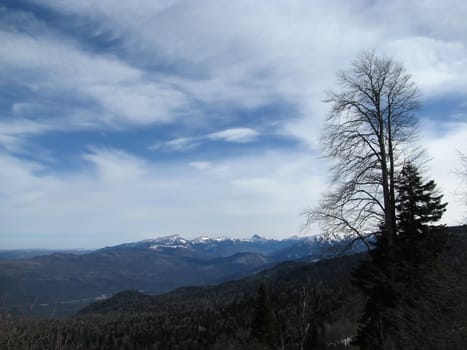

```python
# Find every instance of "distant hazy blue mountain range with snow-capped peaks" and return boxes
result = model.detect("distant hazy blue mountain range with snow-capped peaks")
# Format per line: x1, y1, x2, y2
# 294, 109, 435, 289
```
0, 235, 361, 315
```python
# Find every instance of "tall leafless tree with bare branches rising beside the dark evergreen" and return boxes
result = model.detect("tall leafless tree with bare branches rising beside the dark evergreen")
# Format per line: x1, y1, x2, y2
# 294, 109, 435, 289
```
306, 51, 419, 250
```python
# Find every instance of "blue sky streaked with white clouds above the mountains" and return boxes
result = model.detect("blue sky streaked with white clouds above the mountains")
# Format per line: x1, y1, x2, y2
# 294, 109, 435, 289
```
0, 0, 467, 249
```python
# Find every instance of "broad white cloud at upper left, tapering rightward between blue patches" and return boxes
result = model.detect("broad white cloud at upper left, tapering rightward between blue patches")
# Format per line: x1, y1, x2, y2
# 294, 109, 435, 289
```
0, 31, 189, 128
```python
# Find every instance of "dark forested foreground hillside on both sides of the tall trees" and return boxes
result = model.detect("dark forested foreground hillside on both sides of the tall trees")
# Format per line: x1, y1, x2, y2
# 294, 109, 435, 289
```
0, 227, 467, 349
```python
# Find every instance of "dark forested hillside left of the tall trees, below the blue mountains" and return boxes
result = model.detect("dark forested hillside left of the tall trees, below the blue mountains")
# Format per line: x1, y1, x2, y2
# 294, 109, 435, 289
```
0, 255, 364, 349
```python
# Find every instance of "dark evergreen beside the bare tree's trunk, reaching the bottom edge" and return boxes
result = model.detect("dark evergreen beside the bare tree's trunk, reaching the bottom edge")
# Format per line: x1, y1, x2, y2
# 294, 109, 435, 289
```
354, 162, 447, 350
